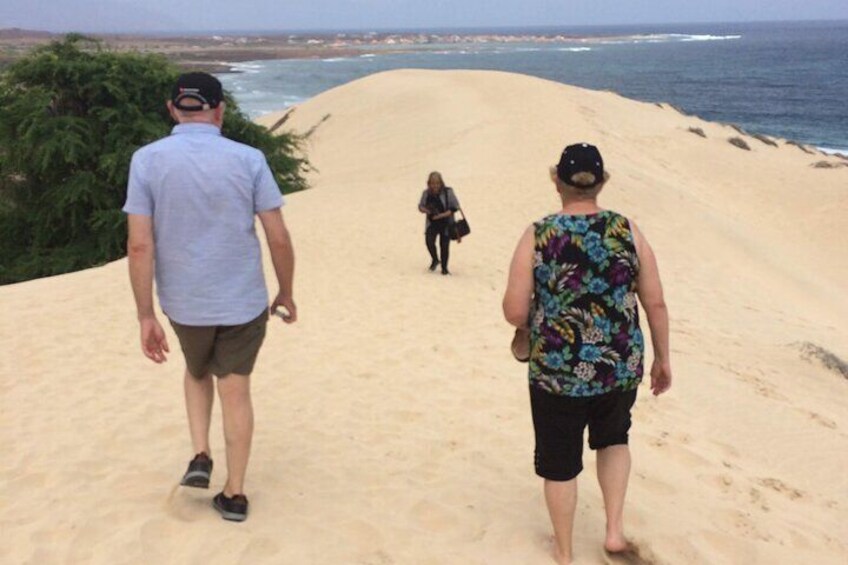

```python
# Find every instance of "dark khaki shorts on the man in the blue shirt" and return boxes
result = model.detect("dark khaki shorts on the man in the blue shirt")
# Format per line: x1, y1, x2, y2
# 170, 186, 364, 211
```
169, 310, 268, 378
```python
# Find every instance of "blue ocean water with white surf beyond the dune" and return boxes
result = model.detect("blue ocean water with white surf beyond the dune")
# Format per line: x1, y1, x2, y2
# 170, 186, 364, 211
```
220, 21, 848, 154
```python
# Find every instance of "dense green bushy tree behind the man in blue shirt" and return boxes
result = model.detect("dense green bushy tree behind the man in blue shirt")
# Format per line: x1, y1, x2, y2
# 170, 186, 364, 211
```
0, 34, 309, 284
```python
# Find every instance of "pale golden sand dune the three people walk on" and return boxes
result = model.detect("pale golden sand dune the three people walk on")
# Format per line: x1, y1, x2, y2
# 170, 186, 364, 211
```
0, 70, 848, 565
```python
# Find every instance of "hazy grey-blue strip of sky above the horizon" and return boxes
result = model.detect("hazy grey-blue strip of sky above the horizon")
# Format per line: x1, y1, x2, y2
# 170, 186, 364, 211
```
0, 0, 848, 33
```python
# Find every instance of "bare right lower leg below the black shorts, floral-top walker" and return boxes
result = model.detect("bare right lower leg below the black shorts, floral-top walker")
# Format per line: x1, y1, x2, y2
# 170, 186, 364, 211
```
597, 444, 630, 551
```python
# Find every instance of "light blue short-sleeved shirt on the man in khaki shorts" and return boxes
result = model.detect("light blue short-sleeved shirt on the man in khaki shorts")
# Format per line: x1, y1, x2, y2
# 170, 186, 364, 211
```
123, 123, 283, 326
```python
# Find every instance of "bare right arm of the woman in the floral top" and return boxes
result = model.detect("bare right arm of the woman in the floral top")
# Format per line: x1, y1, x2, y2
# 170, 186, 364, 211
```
630, 222, 671, 395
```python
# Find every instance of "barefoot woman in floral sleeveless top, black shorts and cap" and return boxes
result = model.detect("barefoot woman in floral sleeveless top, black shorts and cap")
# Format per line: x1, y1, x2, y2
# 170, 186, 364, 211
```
503, 143, 671, 563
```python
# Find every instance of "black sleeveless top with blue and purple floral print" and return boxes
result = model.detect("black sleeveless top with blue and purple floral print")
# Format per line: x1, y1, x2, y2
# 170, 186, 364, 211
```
529, 210, 644, 397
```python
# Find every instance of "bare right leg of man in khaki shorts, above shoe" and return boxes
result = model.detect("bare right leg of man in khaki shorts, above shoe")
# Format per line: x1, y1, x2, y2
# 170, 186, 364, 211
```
218, 373, 253, 497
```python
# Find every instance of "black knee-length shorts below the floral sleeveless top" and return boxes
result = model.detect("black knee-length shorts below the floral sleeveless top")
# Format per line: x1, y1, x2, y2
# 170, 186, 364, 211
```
530, 385, 636, 481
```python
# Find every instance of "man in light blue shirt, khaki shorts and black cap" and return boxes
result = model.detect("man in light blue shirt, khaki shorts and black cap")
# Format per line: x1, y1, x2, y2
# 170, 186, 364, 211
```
124, 73, 297, 521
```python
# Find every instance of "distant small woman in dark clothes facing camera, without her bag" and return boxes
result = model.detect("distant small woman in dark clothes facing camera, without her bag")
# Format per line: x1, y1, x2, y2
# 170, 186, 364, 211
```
418, 171, 459, 275
